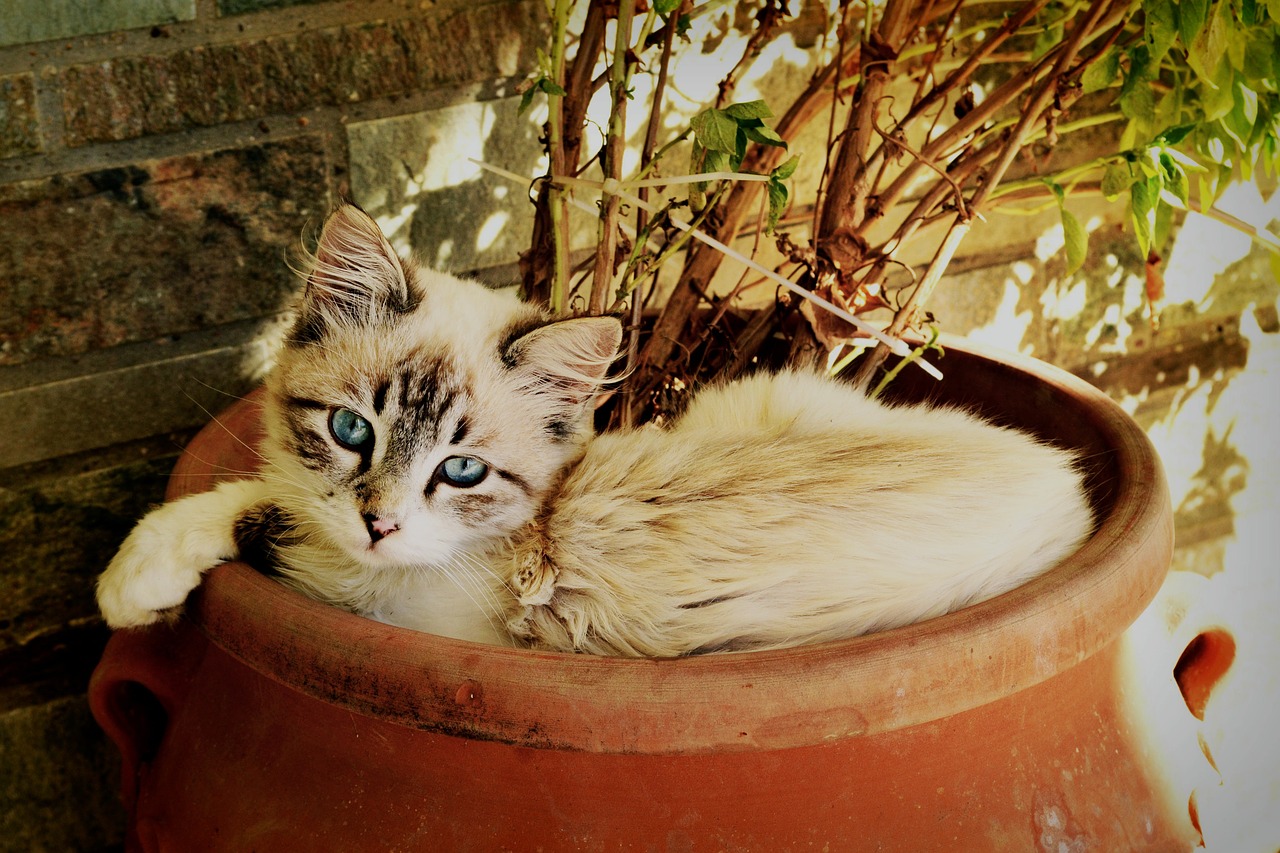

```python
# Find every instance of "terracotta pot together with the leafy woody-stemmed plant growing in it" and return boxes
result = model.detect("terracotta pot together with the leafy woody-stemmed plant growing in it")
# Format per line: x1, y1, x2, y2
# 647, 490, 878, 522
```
91, 0, 1280, 849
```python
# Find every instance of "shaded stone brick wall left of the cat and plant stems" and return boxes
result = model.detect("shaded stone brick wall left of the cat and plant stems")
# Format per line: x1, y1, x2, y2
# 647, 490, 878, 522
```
0, 0, 544, 850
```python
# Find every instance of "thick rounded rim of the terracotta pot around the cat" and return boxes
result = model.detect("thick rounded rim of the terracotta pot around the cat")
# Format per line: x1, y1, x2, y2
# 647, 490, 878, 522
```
175, 341, 1172, 754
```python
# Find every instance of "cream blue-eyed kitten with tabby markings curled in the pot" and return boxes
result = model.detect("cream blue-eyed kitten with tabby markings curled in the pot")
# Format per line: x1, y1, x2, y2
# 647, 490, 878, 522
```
97, 205, 1093, 657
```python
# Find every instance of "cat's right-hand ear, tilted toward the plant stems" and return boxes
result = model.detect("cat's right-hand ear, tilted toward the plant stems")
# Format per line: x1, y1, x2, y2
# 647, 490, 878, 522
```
502, 316, 622, 407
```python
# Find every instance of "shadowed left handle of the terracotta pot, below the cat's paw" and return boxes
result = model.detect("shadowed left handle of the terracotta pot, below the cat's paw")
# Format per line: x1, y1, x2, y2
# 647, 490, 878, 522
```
88, 620, 202, 826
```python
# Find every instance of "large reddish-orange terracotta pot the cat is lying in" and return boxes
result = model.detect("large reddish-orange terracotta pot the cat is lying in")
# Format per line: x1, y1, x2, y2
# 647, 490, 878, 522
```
90, 345, 1196, 850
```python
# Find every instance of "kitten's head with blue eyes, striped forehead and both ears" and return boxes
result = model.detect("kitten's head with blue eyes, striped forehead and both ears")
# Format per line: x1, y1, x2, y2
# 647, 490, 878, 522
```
265, 206, 621, 569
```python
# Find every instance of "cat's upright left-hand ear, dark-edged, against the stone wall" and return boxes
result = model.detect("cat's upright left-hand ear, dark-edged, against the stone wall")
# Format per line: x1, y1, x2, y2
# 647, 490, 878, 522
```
293, 205, 419, 342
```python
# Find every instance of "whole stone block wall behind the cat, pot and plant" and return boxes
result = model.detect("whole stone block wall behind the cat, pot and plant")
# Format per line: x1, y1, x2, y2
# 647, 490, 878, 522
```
0, 0, 1280, 850
